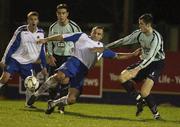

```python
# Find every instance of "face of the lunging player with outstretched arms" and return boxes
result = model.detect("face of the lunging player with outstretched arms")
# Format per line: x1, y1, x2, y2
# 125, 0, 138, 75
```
91, 29, 103, 41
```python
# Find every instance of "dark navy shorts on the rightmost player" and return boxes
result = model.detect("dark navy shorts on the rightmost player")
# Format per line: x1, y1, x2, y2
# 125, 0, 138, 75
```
127, 60, 165, 82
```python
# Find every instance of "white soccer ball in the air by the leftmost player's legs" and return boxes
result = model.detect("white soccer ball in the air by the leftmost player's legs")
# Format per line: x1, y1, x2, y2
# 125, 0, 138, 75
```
24, 76, 39, 91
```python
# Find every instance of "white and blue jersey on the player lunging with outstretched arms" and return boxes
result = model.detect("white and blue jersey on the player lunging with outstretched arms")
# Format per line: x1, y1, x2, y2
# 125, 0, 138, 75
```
63, 32, 103, 68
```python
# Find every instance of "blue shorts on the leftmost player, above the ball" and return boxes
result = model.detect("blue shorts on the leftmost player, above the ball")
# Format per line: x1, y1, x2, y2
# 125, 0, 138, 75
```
4, 58, 33, 79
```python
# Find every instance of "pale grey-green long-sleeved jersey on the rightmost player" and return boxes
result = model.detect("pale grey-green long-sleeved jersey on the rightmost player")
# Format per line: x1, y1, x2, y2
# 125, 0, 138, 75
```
105, 30, 165, 68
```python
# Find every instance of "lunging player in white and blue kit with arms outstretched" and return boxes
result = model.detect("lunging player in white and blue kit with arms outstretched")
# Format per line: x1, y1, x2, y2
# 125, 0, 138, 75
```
28, 26, 140, 114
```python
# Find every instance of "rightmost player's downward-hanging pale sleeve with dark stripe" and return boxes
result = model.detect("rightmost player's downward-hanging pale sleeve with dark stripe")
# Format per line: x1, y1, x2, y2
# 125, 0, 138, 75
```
139, 34, 160, 68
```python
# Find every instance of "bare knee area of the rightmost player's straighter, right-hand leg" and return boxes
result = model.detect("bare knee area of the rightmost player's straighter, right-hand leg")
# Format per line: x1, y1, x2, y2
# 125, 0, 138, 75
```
141, 78, 154, 97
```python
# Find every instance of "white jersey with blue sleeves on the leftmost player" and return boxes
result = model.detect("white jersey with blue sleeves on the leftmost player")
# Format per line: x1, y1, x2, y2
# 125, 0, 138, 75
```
2, 25, 46, 67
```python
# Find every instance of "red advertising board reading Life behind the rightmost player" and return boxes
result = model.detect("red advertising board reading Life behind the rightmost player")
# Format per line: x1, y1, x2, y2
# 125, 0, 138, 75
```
103, 52, 180, 94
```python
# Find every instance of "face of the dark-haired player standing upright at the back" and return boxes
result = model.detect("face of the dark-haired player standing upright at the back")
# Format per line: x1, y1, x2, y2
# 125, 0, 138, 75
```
56, 8, 69, 23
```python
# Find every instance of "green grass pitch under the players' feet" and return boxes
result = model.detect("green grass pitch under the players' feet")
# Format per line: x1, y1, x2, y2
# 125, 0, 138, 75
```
0, 100, 180, 127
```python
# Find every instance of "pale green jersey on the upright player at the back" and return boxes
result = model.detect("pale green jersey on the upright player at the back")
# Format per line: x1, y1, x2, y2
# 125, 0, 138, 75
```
47, 20, 81, 56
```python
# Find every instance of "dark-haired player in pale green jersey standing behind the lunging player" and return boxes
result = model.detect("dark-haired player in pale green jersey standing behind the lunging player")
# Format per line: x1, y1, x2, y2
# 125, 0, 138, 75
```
47, 4, 81, 113
